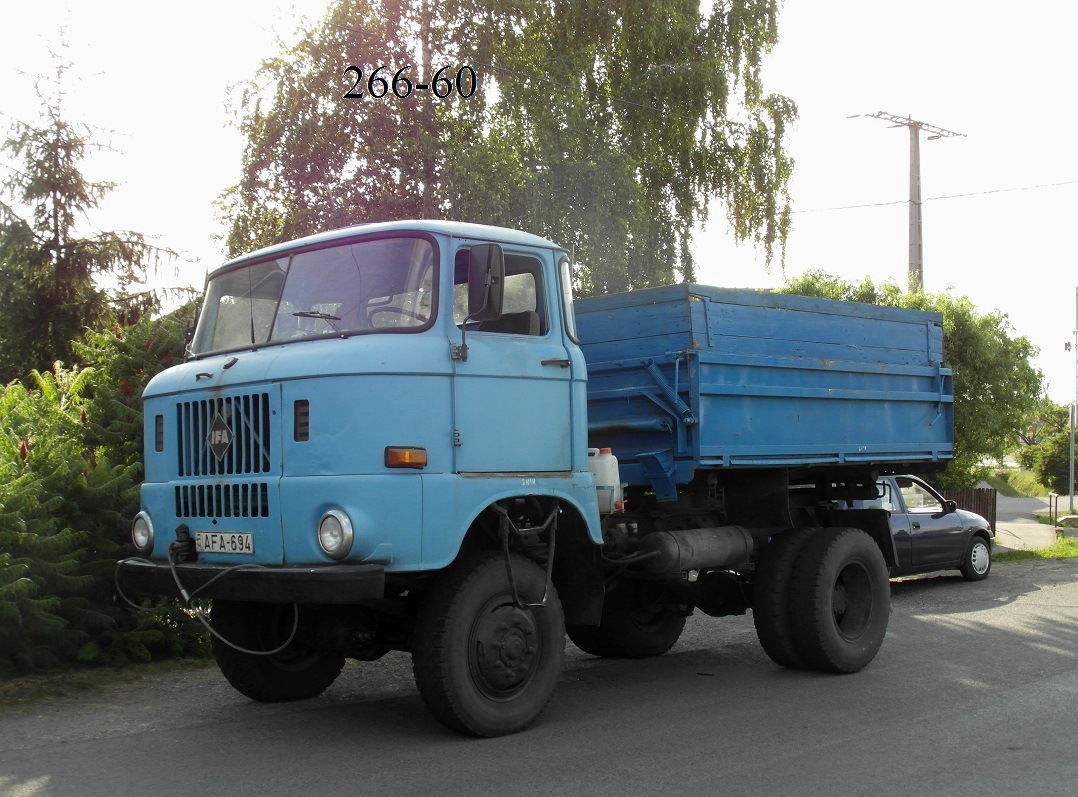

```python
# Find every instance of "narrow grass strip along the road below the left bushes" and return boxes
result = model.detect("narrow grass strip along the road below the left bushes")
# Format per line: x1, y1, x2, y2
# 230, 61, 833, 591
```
0, 659, 213, 710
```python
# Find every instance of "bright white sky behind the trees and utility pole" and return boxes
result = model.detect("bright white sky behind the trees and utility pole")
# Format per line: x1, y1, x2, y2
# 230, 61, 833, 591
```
0, 0, 1078, 403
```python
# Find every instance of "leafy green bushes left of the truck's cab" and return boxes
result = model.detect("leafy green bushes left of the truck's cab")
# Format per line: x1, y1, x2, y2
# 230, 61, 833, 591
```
0, 311, 206, 674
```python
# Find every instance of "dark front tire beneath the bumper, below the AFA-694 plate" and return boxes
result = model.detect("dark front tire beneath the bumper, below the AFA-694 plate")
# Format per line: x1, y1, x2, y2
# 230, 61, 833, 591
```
210, 601, 344, 703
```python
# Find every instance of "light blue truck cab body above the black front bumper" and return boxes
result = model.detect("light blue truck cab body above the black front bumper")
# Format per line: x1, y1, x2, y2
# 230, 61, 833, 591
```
130, 222, 600, 573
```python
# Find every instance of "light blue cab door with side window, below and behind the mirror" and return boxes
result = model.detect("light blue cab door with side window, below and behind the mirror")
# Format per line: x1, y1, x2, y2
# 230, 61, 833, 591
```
453, 249, 572, 473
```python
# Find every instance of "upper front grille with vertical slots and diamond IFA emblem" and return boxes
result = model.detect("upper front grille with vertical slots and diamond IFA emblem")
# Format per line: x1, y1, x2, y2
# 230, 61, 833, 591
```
176, 393, 272, 477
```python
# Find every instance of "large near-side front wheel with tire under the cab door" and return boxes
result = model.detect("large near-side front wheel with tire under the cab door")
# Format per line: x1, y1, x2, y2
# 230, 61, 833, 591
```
412, 553, 565, 737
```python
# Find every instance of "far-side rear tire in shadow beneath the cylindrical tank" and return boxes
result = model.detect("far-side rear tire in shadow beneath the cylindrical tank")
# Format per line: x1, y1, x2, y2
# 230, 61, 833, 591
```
567, 578, 686, 659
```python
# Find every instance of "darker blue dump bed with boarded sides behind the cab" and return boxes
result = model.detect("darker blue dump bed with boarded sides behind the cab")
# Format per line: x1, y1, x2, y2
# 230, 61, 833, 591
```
576, 285, 954, 499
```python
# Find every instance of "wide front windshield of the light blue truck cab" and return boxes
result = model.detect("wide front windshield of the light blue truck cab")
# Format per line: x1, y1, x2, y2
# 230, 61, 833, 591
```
191, 237, 434, 355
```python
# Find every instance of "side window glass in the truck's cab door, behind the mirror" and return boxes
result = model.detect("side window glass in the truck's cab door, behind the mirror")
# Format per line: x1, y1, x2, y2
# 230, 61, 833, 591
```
453, 250, 550, 335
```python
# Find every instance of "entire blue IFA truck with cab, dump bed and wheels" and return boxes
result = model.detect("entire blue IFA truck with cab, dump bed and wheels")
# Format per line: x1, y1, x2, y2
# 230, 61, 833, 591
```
118, 221, 953, 736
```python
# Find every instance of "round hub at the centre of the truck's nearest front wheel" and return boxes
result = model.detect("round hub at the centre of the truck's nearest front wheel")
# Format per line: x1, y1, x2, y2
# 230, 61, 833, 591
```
475, 606, 538, 692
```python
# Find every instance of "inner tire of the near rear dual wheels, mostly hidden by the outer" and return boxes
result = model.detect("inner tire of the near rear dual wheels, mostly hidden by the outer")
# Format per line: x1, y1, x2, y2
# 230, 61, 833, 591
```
752, 528, 819, 670
